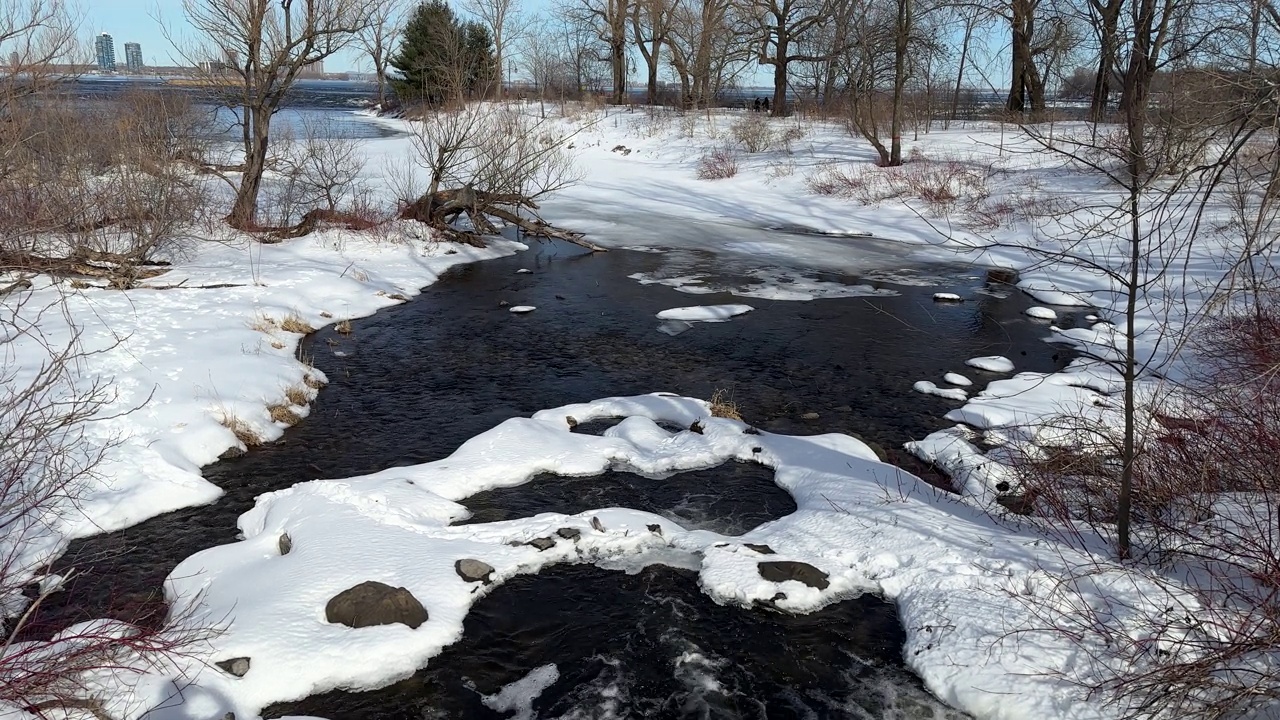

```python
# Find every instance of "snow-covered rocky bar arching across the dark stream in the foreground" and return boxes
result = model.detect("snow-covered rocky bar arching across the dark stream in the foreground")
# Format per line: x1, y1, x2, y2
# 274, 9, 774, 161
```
127, 393, 1152, 720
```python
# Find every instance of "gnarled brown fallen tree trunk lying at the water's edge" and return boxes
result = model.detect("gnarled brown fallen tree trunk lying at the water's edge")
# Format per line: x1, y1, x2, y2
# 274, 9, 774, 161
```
399, 187, 604, 252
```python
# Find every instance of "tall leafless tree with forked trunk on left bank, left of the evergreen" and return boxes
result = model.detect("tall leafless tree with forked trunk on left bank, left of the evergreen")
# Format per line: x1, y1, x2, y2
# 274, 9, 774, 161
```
182, 0, 370, 229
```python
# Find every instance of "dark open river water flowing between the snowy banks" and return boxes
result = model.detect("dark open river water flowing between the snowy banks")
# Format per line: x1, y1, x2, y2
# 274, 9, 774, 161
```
32, 238, 1075, 719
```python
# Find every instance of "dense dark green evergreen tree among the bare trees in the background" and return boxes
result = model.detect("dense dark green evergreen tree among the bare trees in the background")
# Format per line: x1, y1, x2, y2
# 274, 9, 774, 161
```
390, 0, 497, 104
